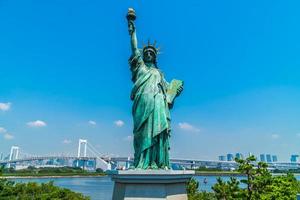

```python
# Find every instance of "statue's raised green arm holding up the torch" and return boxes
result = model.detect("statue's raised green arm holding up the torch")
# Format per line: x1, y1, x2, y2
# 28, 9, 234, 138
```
126, 8, 139, 55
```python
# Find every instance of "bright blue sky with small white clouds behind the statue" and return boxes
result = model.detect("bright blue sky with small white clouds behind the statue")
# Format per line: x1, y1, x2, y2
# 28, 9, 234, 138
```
0, 0, 300, 160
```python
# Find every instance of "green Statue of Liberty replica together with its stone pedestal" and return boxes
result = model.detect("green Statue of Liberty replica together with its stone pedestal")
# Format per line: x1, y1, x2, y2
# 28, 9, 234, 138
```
112, 8, 195, 200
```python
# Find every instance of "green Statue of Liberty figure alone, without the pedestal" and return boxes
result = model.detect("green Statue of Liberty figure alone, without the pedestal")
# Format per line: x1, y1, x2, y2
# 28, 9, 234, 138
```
127, 8, 183, 169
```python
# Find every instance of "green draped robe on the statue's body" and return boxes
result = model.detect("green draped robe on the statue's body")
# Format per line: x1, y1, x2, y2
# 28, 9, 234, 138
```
129, 54, 170, 169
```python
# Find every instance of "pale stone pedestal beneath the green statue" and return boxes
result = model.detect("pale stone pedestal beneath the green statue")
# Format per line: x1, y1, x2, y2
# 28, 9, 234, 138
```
112, 170, 195, 200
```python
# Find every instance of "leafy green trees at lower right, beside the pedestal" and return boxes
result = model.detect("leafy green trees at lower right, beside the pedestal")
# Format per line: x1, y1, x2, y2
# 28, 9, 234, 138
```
212, 156, 300, 200
